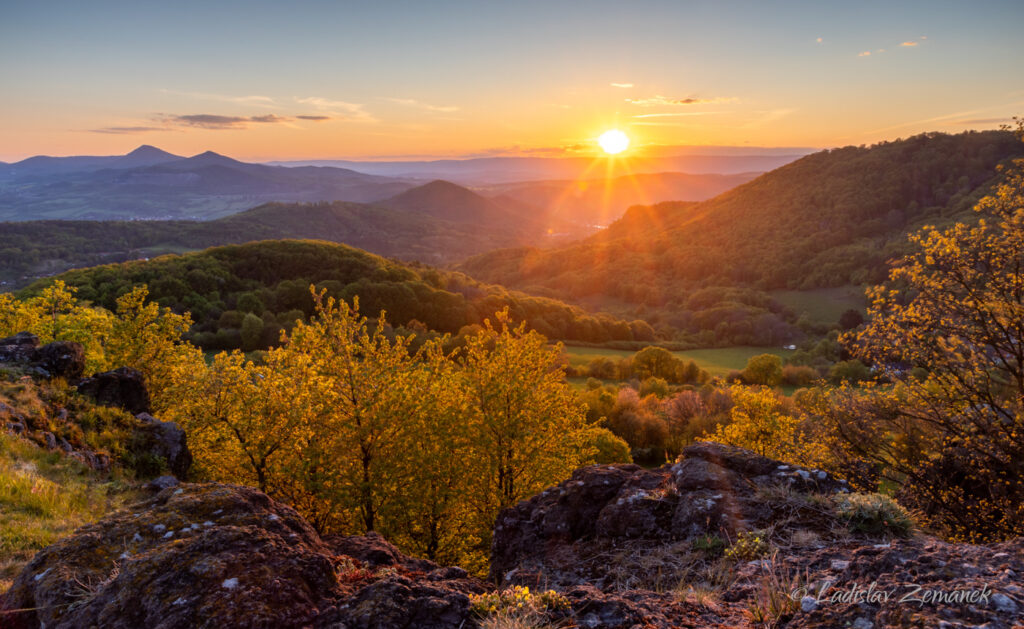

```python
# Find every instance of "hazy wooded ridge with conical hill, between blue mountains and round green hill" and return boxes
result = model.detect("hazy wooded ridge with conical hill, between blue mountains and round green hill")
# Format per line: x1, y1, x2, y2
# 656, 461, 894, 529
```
0, 196, 542, 286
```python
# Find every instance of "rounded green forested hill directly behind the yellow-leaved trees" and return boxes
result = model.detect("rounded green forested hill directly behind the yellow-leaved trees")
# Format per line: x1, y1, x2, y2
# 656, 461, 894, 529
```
23, 240, 654, 349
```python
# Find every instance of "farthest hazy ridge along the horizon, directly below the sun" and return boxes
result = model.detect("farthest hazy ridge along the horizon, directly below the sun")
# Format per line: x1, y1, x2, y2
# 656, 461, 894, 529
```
271, 149, 811, 185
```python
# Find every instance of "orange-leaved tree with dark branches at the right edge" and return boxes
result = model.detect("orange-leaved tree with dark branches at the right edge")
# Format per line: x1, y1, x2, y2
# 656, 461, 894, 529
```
845, 121, 1024, 540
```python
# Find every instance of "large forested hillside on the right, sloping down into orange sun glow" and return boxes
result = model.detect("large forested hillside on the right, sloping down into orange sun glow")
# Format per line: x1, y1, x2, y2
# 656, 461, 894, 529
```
461, 131, 1024, 306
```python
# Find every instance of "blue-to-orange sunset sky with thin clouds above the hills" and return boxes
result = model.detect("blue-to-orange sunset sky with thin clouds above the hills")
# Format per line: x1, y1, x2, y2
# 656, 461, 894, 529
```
0, 0, 1024, 162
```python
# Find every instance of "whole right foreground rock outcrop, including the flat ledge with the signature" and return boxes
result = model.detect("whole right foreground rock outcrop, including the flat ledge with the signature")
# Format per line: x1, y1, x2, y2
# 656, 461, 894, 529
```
490, 443, 1024, 629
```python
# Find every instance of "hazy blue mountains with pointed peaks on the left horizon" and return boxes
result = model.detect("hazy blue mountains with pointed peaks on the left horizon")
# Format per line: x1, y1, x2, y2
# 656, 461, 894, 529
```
0, 145, 416, 221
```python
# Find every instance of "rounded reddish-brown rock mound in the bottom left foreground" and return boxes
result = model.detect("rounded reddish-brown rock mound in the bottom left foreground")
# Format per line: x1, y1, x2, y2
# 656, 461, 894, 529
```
0, 484, 488, 629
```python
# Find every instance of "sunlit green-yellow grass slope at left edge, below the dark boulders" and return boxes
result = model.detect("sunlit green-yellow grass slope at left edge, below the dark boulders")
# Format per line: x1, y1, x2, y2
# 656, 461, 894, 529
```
0, 434, 137, 592
